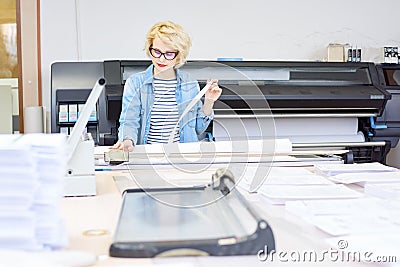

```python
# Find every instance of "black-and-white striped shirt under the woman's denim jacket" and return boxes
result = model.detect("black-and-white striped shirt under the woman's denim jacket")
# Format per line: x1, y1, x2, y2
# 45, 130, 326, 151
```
147, 79, 179, 144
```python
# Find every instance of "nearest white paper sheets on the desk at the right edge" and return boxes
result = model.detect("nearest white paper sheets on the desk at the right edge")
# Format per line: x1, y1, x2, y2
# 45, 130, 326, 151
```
285, 197, 400, 236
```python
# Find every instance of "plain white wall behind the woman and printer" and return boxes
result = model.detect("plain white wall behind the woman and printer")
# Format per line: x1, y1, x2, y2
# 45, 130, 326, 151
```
41, 0, 400, 110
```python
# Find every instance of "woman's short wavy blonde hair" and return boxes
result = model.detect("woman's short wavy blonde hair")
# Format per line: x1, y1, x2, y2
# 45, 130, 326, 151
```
145, 21, 192, 68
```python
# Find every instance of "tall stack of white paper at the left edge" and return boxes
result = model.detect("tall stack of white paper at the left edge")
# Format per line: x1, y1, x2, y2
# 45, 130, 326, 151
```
0, 134, 67, 250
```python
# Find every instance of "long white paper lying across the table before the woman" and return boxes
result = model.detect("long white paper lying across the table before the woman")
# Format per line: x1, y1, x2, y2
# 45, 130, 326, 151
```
95, 139, 342, 170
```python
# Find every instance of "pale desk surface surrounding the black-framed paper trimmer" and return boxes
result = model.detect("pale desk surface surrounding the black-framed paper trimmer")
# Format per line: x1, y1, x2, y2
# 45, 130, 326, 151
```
58, 171, 376, 267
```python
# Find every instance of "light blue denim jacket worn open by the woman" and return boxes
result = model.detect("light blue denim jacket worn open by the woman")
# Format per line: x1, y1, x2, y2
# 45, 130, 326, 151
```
118, 65, 214, 145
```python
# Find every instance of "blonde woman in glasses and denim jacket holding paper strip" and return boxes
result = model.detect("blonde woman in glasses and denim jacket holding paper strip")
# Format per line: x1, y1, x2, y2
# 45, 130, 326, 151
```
113, 21, 222, 151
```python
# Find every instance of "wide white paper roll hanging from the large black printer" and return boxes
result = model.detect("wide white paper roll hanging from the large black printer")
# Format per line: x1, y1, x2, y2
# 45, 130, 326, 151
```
213, 116, 365, 143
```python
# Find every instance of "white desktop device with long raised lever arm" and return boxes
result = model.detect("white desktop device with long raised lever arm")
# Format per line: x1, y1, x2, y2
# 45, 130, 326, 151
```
64, 78, 105, 196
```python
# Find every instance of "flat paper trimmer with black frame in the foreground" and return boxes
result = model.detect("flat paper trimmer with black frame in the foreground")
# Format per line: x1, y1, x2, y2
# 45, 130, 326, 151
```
109, 170, 275, 258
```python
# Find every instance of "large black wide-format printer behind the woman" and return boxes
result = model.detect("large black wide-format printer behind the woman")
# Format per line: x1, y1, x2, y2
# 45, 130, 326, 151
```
52, 60, 400, 163
